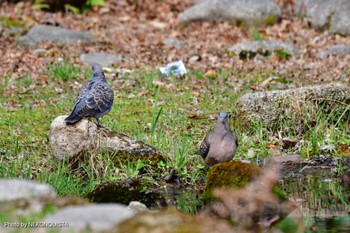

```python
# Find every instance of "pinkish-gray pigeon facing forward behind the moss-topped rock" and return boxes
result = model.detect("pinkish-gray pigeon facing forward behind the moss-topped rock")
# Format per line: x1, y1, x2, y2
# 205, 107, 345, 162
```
198, 111, 238, 165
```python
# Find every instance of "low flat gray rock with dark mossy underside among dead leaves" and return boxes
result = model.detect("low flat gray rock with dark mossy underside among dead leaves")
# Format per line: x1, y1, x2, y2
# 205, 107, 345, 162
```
229, 40, 299, 57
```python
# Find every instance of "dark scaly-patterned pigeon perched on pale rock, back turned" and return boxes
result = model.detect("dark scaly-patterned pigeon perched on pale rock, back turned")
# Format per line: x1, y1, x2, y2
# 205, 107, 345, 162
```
64, 64, 114, 126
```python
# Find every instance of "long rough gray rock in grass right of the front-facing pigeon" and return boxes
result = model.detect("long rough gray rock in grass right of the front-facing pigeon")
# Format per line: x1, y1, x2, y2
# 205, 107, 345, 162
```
235, 83, 350, 130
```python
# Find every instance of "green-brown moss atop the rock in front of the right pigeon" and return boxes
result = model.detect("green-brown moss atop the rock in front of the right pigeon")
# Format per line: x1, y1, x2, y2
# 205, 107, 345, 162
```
203, 161, 262, 200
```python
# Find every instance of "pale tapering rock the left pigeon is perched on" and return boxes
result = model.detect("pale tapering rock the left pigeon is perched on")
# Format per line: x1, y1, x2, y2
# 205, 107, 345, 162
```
49, 116, 159, 160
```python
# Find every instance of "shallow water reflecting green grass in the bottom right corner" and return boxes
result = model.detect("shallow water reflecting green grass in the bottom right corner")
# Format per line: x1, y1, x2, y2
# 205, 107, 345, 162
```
278, 167, 350, 233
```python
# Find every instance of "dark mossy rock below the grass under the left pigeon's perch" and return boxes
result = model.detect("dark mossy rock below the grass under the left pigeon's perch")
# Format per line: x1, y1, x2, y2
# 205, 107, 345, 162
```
87, 178, 167, 208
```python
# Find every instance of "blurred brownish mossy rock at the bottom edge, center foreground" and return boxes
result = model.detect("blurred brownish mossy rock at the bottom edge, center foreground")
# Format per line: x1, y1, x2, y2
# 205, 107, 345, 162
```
109, 208, 236, 233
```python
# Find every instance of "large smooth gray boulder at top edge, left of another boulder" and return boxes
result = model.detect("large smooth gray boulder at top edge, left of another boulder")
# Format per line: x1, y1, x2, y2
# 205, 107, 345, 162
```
180, 0, 282, 25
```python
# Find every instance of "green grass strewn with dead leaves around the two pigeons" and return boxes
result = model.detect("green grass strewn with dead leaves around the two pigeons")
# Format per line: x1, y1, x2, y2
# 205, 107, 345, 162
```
0, 62, 350, 221
